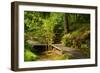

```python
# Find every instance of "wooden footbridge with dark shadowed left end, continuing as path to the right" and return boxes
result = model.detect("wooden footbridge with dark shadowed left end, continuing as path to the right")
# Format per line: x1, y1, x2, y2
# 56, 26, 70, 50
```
33, 44, 86, 59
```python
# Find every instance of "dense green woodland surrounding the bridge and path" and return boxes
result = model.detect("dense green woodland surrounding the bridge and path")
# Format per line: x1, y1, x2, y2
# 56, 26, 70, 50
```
24, 11, 90, 61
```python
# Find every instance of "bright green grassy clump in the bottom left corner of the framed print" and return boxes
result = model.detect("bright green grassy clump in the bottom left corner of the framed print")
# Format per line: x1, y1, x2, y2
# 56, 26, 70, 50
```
24, 50, 38, 61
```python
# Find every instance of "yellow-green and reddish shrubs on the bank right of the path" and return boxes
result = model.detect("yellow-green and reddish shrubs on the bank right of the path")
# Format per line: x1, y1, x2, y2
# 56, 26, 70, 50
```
61, 25, 90, 57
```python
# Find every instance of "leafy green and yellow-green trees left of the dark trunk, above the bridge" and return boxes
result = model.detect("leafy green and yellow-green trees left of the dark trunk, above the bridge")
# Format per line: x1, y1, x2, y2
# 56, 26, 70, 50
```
24, 11, 63, 44
